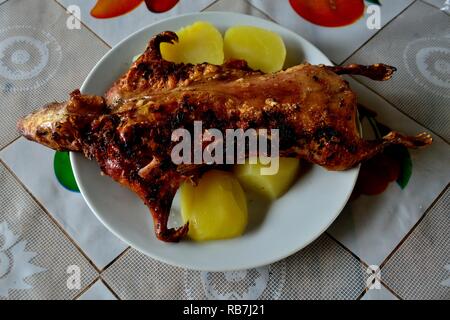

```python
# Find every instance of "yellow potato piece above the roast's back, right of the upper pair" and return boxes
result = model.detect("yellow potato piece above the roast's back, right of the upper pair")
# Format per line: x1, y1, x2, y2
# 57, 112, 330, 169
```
224, 26, 286, 73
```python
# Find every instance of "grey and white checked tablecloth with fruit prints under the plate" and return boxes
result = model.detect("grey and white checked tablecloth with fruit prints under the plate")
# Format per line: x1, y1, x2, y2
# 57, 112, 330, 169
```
0, 0, 450, 299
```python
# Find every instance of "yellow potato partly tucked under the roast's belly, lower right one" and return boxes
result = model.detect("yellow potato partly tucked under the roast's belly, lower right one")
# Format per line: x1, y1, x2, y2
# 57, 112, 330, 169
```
234, 158, 300, 200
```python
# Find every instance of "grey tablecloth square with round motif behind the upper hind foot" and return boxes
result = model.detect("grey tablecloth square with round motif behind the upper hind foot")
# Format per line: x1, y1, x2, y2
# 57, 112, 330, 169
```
347, 1, 450, 144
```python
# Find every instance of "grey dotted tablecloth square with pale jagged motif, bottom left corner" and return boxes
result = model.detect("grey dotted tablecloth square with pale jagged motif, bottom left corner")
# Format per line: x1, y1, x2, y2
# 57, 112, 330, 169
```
0, 162, 98, 300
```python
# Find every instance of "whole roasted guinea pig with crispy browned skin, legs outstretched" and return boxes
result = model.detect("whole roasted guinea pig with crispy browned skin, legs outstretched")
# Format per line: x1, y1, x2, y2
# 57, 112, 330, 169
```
18, 32, 432, 242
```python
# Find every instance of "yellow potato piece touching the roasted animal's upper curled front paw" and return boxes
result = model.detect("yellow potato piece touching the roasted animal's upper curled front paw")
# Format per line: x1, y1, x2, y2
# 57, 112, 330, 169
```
161, 21, 224, 65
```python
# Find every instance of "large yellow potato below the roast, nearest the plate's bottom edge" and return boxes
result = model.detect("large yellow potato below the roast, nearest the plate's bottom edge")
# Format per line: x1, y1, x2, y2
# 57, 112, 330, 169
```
181, 170, 248, 241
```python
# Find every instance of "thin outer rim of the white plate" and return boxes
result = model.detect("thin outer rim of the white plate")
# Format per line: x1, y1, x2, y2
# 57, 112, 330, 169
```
70, 11, 360, 272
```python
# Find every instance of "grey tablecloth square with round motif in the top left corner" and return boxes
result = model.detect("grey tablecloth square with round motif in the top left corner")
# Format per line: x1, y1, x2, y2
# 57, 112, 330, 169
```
0, 0, 112, 147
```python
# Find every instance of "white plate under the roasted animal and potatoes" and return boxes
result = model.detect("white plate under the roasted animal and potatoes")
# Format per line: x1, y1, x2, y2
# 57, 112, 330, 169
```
70, 12, 359, 271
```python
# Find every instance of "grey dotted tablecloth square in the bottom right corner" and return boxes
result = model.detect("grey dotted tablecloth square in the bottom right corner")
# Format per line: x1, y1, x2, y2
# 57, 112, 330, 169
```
383, 188, 450, 300
